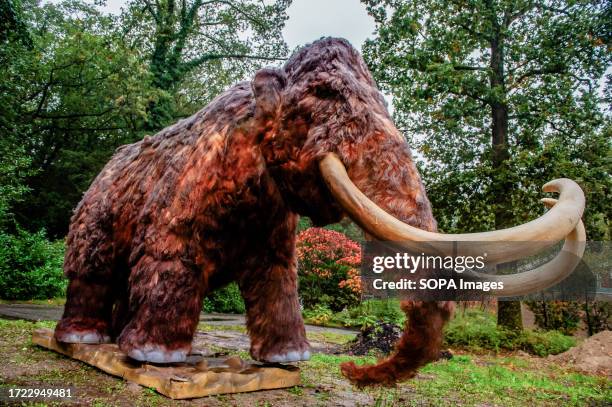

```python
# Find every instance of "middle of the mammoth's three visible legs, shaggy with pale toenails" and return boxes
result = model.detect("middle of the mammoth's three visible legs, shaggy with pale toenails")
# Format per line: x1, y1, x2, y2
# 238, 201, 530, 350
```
117, 255, 204, 363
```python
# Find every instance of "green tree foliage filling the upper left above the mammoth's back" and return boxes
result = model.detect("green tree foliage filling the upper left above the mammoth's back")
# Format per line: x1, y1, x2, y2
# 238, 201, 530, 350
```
0, 0, 288, 238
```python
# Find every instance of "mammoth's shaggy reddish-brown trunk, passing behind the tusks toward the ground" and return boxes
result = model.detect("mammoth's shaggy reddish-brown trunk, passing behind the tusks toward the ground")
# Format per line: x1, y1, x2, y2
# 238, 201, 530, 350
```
334, 133, 454, 386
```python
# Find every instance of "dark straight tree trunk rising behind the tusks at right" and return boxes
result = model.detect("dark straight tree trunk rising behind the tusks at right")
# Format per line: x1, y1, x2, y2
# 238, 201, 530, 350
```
490, 22, 523, 331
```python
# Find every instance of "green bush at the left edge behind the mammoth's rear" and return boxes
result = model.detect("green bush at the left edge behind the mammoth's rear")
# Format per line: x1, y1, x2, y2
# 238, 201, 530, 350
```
0, 229, 67, 300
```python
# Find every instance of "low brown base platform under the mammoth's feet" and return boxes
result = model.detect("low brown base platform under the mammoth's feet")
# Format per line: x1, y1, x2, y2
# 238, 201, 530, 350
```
32, 329, 300, 399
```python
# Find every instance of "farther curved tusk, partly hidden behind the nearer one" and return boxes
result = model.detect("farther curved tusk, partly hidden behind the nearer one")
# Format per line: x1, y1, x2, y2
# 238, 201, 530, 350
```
467, 198, 586, 297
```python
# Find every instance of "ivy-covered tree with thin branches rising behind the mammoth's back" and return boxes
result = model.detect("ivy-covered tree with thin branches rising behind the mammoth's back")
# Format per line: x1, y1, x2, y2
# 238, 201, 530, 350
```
122, 0, 291, 131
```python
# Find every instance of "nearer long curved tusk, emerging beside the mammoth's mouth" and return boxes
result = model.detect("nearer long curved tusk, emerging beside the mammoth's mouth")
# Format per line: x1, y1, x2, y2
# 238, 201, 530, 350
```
319, 153, 584, 263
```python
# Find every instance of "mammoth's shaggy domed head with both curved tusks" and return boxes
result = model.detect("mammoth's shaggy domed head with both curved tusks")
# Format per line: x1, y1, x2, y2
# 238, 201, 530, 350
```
252, 38, 586, 296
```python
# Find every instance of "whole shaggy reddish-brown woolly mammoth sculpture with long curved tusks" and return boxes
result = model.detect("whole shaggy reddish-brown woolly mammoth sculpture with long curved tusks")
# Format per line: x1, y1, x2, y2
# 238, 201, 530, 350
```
55, 38, 584, 384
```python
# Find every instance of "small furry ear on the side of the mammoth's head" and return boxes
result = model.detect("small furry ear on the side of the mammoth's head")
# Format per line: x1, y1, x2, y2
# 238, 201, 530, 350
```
251, 68, 287, 119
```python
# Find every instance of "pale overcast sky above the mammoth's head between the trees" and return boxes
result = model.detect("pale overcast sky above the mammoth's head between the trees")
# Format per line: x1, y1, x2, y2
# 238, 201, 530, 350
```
93, 0, 374, 50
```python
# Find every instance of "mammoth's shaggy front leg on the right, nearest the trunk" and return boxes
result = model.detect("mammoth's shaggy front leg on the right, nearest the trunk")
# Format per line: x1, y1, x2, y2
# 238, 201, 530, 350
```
240, 258, 310, 362
